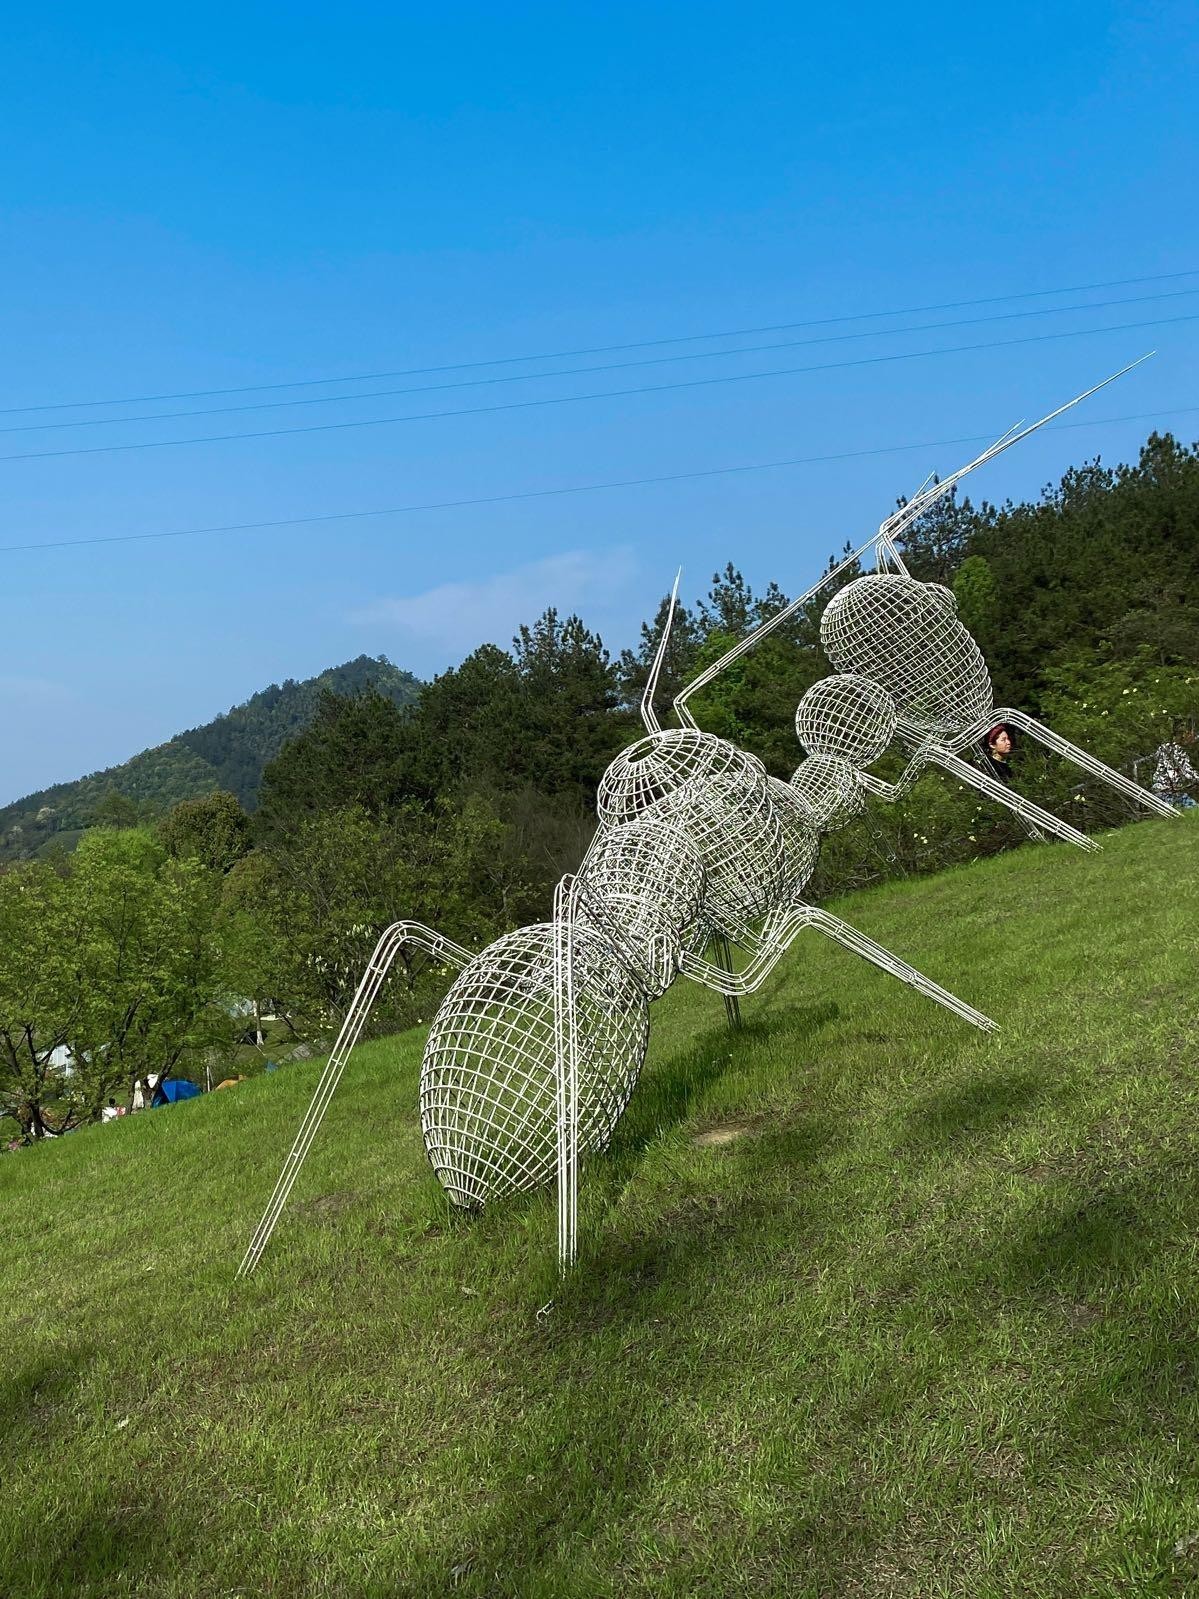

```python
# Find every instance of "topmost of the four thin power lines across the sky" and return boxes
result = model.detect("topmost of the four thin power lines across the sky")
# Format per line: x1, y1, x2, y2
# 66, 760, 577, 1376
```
0, 267, 1199, 416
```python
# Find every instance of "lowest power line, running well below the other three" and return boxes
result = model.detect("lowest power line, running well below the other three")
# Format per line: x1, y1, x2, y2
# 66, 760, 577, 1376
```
0, 406, 1199, 555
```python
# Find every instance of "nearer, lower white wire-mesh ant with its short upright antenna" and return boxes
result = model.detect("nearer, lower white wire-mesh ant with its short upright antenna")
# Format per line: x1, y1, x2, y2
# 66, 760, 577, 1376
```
238, 579, 994, 1274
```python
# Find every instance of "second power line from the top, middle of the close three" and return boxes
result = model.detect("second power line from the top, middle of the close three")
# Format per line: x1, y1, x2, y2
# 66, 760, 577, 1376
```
0, 288, 1199, 433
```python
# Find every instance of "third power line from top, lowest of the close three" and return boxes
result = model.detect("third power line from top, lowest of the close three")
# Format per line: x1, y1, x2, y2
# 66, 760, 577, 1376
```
0, 313, 1199, 462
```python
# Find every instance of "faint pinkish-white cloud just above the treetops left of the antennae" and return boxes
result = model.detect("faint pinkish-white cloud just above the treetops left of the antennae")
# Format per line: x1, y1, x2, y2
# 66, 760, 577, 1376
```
352, 545, 639, 654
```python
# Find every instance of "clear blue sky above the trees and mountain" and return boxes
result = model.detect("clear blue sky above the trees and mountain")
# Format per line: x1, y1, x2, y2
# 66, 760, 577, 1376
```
0, 0, 1199, 801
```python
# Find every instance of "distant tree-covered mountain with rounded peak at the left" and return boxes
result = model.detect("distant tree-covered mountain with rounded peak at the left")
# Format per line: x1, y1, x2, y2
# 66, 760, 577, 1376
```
0, 656, 420, 862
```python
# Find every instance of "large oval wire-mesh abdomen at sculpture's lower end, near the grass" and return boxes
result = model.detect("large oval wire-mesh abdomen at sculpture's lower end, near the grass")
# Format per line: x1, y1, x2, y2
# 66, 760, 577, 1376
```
420, 923, 649, 1209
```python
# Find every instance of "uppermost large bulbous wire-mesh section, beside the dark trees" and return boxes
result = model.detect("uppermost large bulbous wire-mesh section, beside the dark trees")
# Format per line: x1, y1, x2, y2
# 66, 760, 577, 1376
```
820, 572, 994, 737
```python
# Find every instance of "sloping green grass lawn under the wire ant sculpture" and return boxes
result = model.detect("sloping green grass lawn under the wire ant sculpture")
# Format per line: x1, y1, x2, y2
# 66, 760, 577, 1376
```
0, 817, 1199, 1599
